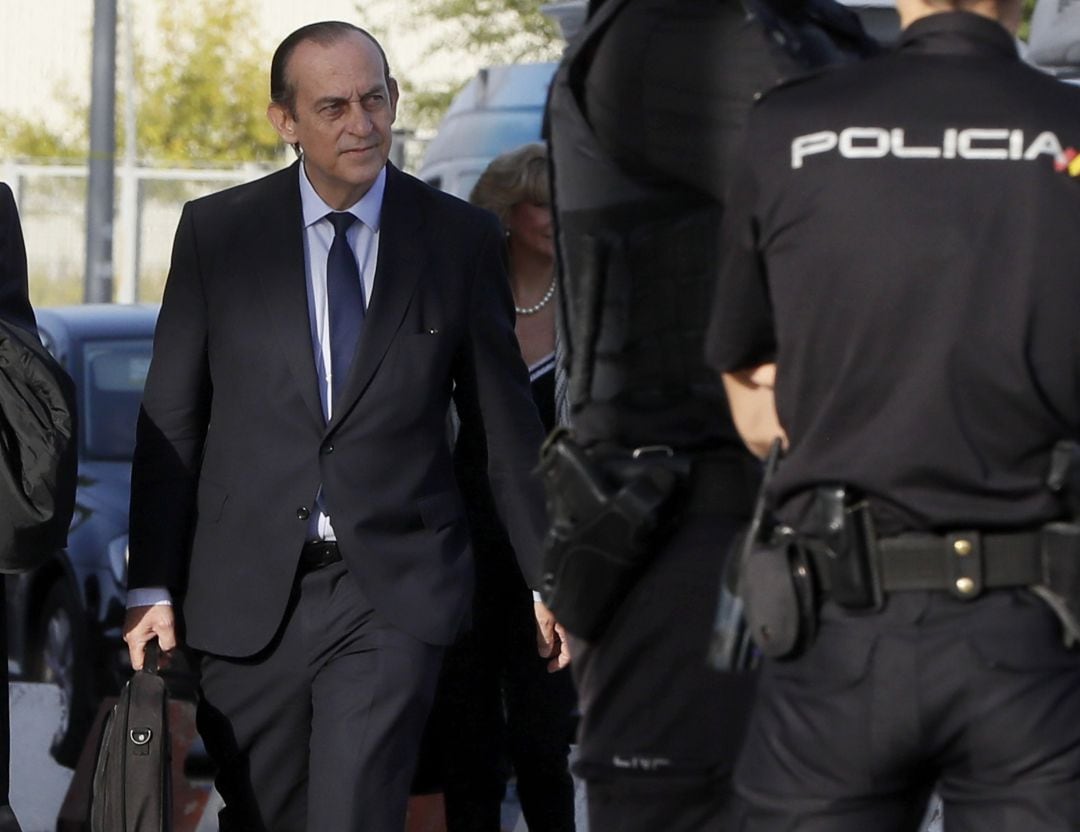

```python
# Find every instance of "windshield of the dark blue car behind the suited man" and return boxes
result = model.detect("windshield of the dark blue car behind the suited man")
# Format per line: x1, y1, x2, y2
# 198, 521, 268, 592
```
80, 338, 153, 461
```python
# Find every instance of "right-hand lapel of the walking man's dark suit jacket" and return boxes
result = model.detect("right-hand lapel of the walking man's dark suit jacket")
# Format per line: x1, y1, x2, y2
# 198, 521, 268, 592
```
330, 164, 428, 428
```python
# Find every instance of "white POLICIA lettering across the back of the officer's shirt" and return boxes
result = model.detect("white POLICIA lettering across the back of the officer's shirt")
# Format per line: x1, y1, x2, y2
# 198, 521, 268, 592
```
792, 128, 1067, 169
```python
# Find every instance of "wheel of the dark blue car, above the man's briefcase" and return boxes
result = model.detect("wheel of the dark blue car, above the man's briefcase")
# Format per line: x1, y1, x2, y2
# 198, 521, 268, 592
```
35, 582, 94, 768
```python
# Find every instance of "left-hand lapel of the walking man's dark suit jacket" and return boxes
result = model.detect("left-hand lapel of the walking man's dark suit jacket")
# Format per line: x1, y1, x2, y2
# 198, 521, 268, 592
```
253, 162, 323, 424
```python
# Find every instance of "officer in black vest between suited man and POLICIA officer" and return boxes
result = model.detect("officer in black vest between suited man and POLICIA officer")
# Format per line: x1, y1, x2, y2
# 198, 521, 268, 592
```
543, 0, 865, 832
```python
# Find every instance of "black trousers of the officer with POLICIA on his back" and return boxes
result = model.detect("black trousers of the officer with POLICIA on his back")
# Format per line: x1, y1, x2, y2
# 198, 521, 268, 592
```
735, 589, 1080, 832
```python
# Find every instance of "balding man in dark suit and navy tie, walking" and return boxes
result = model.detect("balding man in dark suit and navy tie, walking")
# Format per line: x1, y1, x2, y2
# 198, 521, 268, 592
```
125, 23, 568, 832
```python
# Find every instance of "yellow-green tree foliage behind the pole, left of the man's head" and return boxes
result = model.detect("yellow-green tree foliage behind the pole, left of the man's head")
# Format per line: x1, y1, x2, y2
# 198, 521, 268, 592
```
0, 0, 282, 164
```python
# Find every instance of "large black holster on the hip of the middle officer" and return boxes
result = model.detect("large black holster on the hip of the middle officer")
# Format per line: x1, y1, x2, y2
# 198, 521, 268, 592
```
540, 428, 689, 641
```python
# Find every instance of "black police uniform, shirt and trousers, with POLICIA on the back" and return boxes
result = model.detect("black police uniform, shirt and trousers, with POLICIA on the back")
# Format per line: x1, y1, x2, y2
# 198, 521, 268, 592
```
707, 13, 1080, 832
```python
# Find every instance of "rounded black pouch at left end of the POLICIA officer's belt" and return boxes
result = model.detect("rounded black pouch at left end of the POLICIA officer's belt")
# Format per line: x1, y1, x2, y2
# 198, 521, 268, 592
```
738, 527, 818, 659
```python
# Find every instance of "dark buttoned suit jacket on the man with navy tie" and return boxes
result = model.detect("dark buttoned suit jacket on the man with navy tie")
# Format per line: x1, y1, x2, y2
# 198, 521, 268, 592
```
129, 164, 544, 656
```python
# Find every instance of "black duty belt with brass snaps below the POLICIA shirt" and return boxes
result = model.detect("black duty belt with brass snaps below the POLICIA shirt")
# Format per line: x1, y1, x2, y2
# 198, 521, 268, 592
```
809, 531, 1043, 599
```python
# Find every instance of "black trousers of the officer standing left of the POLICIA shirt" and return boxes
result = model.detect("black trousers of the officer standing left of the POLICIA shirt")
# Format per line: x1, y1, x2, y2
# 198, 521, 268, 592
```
570, 518, 754, 832
